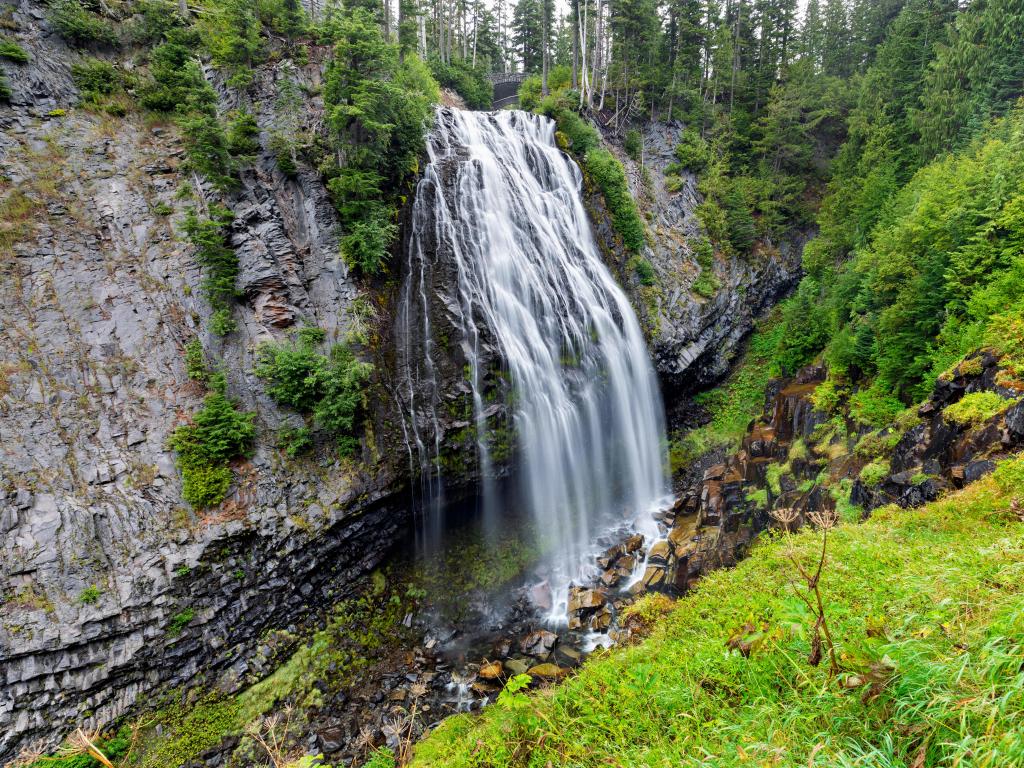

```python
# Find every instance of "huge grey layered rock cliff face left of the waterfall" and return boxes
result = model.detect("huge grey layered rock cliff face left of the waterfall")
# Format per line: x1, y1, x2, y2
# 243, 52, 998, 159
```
0, 9, 408, 762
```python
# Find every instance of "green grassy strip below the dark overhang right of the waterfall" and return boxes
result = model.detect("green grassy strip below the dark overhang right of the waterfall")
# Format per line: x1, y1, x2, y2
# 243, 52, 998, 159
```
670, 314, 781, 471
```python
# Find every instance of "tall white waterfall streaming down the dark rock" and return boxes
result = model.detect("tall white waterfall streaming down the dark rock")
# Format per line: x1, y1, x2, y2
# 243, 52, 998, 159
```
398, 110, 668, 634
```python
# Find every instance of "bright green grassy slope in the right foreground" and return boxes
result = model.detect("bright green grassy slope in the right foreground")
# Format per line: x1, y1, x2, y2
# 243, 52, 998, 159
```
414, 457, 1024, 768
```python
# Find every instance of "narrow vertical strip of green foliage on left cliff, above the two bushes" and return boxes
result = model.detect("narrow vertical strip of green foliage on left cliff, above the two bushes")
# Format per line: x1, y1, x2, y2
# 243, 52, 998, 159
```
182, 203, 239, 336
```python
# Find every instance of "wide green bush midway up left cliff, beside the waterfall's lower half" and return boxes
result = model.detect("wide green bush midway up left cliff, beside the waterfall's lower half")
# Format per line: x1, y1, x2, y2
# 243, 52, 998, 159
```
255, 328, 373, 456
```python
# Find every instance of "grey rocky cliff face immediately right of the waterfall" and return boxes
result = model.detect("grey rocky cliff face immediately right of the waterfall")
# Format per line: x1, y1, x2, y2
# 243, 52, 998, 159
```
591, 123, 804, 399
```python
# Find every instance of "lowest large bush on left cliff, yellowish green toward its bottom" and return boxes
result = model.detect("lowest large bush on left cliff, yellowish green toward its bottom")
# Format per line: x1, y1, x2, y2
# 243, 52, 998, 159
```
169, 374, 256, 509
